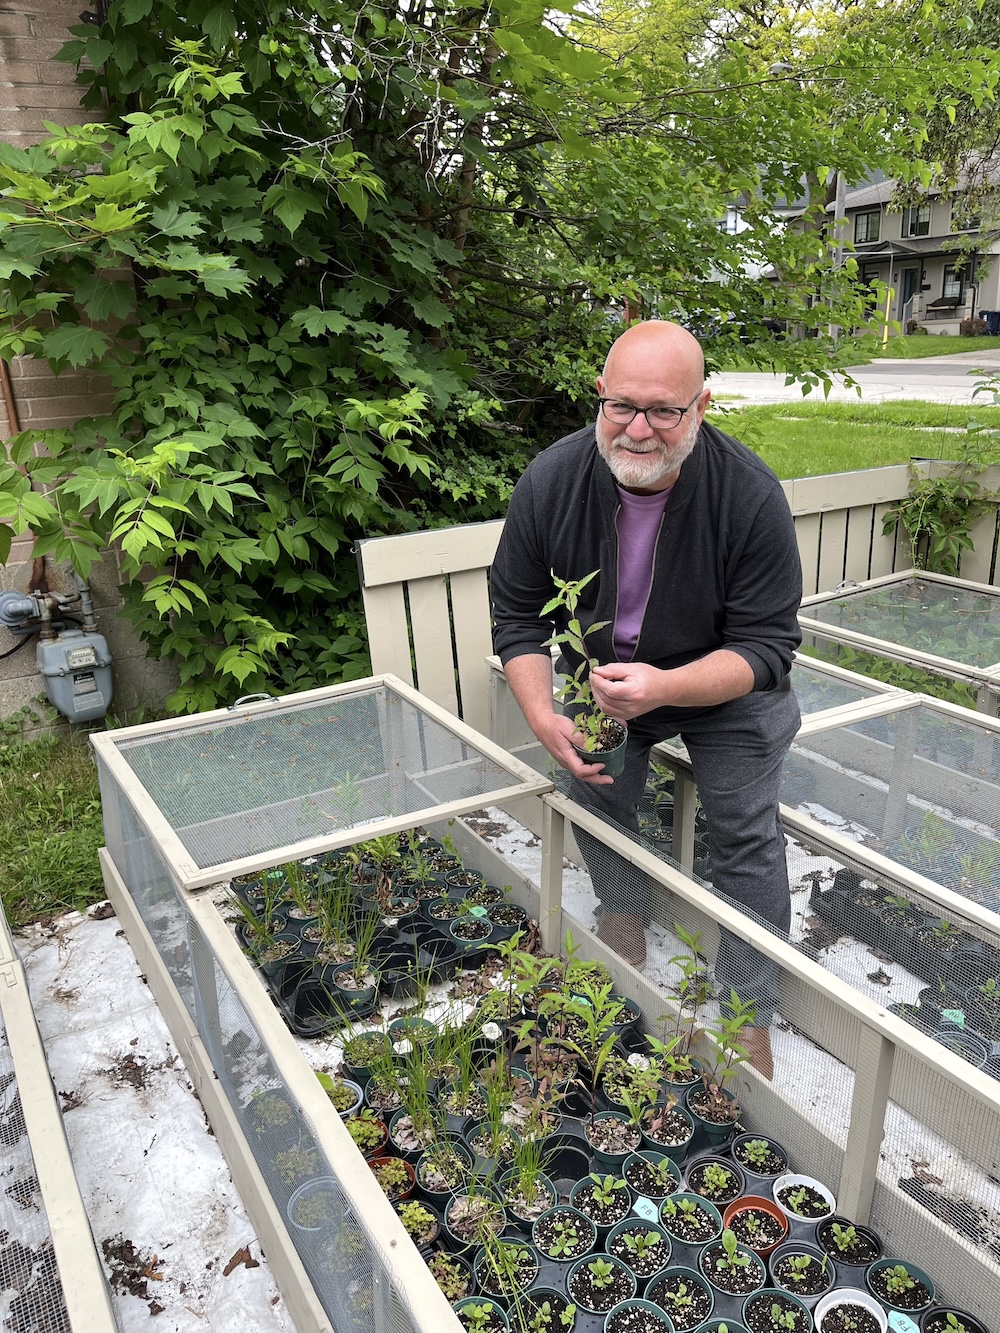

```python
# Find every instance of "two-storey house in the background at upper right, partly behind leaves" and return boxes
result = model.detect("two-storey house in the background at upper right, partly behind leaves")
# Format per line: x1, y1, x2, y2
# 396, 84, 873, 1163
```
828, 177, 1000, 333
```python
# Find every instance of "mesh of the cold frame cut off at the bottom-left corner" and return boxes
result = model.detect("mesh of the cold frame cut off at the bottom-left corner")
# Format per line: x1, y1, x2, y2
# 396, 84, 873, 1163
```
0, 1022, 71, 1333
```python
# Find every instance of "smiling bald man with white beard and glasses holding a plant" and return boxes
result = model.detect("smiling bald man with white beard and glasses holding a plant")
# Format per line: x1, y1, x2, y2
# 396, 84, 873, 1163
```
491, 320, 801, 1077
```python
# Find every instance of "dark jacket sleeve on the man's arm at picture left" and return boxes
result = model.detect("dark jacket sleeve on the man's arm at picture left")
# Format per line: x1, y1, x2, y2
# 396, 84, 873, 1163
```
489, 467, 565, 667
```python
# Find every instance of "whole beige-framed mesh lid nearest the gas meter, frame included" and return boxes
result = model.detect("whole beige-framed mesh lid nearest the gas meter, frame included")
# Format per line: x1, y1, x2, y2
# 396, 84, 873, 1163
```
91, 676, 552, 889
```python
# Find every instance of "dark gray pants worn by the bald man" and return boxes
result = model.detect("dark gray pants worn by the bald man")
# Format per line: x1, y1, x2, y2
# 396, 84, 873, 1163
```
569, 680, 800, 1026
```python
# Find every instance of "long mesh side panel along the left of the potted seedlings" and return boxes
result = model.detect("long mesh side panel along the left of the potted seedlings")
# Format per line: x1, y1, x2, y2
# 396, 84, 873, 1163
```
188, 920, 413, 1333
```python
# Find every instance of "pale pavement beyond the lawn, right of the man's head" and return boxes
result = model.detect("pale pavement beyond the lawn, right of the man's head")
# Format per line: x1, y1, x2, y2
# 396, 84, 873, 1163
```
708, 349, 1000, 405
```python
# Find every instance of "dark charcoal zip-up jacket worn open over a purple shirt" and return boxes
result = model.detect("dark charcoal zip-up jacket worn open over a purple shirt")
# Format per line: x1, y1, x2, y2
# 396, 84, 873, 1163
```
491, 425, 801, 690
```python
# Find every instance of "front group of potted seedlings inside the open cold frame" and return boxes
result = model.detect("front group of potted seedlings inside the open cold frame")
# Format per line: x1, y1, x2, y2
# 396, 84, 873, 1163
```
233, 831, 980, 1333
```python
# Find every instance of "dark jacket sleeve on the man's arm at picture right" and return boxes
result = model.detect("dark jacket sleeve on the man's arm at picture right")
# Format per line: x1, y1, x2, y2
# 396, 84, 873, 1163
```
721, 485, 803, 689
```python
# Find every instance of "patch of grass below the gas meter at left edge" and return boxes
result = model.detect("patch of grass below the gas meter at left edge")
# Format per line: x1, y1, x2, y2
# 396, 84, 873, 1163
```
0, 730, 105, 928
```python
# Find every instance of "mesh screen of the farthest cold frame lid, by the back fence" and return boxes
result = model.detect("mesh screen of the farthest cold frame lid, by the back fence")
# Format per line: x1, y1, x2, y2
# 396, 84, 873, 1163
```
803, 579, 1000, 668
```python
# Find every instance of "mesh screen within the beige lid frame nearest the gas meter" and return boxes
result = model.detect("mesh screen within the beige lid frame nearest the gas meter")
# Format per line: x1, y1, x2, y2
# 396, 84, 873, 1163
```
108, 686, 512, 869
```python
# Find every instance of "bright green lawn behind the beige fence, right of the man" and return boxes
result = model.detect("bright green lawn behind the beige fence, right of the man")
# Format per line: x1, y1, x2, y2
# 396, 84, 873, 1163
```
709, 394, 1000, 480
